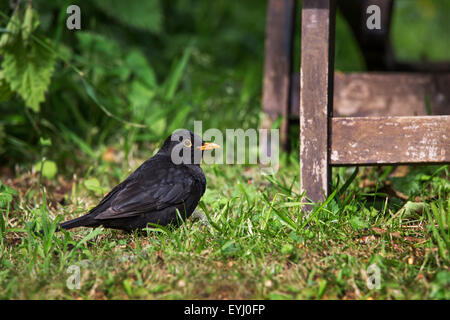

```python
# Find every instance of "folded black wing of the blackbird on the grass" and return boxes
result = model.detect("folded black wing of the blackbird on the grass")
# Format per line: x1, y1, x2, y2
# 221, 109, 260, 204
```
95, 162, 198, 220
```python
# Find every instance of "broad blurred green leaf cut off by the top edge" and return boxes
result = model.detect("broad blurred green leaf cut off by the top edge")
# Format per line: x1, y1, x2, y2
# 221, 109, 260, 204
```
95, 0, 163, 33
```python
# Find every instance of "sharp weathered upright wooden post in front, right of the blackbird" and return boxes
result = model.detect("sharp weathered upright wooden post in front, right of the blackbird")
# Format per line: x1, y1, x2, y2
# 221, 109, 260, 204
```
299, 0, 335, 204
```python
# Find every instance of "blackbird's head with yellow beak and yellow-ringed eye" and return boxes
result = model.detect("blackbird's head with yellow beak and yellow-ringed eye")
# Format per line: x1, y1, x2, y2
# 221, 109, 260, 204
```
158, 129, 220, 165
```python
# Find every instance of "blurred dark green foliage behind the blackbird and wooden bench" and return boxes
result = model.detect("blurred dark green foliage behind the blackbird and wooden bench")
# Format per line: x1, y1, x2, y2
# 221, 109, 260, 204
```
0, 0, 450, 173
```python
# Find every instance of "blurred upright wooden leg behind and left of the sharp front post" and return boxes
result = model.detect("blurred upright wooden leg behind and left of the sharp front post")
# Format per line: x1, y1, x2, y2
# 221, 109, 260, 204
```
261, 0, 295, 149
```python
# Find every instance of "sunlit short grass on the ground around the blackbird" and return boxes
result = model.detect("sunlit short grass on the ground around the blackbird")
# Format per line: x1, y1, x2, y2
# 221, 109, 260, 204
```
0, 149, 450, 299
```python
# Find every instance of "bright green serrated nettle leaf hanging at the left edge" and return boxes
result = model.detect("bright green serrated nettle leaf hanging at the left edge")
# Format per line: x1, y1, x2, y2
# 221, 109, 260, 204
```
2, 37, 55, 112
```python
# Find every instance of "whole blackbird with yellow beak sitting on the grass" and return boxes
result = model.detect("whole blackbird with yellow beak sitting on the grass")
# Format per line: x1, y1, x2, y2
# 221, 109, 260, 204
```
60, 129, 219, 231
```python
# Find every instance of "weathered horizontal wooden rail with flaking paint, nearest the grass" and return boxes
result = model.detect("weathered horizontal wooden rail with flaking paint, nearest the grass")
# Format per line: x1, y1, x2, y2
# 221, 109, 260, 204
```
330, 116, 450, 165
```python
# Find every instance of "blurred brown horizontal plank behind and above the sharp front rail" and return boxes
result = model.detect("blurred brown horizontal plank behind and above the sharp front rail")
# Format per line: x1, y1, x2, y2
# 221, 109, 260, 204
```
291, 72, 450, 117
